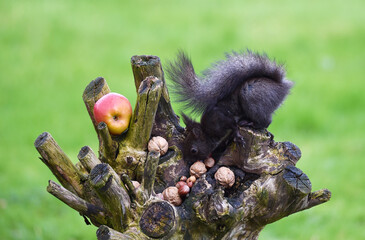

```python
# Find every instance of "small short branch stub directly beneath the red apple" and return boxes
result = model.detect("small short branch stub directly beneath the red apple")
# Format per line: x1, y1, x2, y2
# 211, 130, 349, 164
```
97, 122, 118, 164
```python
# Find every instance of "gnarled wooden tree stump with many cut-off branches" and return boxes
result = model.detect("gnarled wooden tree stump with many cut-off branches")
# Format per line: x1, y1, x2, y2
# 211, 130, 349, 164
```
35, 56, 331, 240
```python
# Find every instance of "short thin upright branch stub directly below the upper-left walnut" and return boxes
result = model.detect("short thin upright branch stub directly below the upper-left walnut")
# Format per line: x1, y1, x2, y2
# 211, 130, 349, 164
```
142, 152, 160, 199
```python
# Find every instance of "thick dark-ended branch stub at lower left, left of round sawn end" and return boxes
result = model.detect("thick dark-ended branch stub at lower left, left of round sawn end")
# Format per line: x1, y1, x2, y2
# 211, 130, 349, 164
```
90, 163, 131, 231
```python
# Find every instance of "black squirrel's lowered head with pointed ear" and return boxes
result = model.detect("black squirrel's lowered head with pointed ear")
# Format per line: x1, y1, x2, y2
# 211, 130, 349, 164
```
182, 114, 212, 162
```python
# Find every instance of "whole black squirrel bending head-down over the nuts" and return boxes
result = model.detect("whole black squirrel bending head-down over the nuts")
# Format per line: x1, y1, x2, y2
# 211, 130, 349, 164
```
167, 50, 293, 162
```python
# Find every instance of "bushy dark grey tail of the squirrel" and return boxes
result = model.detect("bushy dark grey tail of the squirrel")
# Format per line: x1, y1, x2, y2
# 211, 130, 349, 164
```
167, 51, 290, 112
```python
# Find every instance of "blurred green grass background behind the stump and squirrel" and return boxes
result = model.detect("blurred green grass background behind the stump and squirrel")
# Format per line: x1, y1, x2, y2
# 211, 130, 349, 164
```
0, 0, 365, 240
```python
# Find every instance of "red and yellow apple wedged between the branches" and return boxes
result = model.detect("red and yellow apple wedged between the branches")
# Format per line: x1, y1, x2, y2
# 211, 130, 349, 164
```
94, 93, 132, 135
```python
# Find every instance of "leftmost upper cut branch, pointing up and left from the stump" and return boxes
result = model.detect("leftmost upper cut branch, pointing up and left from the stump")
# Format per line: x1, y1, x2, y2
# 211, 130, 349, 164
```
34, 132, 84, 196
